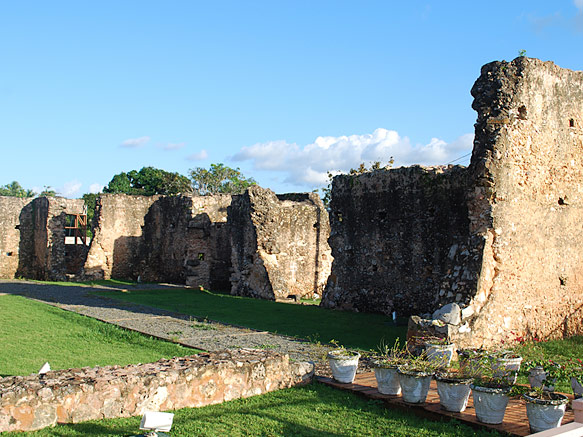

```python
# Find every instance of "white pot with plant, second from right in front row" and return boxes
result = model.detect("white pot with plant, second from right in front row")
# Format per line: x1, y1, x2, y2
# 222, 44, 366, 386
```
470, 355, 512, 424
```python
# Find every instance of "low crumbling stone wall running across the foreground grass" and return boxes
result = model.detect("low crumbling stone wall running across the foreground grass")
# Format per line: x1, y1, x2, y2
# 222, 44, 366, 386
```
0, 349, 313, 432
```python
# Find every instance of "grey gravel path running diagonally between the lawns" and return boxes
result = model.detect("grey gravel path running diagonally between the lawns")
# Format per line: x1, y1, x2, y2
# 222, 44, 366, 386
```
0, 280, 367, 375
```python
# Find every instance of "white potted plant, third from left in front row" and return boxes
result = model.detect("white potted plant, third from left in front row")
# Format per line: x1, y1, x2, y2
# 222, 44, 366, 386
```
397, 352, 440, 404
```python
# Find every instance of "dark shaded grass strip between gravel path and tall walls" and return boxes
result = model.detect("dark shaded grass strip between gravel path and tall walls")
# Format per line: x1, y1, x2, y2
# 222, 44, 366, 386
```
97, 289, 407, 350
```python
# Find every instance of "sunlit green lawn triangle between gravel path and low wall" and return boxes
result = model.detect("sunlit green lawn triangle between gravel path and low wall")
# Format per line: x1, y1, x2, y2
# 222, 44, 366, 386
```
0, 295, 197, 376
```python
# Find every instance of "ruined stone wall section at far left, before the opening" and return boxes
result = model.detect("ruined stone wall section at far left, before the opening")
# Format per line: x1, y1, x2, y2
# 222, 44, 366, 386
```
0, 196, 87, 281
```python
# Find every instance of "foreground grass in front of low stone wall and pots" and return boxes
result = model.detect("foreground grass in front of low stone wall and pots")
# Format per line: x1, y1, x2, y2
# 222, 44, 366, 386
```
2, 383, 500, 437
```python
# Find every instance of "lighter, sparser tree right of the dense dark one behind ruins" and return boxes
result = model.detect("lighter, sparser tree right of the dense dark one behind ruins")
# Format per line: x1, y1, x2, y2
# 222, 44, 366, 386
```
189, 164, 257, 196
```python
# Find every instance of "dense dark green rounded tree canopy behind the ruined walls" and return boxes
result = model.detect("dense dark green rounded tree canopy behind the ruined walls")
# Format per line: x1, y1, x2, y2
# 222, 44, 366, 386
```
103, 167, 192, 196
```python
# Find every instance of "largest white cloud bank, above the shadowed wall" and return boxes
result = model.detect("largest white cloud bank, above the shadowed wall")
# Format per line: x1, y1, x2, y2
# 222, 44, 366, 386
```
232, 128, 473, 188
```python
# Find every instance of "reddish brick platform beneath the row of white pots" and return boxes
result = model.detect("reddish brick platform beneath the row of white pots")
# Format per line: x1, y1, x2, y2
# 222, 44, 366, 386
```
317, 372, 574, 436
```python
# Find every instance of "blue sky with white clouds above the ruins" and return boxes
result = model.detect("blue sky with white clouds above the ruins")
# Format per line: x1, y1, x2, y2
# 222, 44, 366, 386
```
0, 0, 583, 197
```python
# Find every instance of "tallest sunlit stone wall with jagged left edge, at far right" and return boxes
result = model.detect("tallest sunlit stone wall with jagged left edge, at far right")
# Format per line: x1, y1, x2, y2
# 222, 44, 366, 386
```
456, 57, 583, 344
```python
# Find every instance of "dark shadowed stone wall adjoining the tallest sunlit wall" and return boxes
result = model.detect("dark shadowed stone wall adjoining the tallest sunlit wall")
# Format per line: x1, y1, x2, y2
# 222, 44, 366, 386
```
322, 166, 479, 315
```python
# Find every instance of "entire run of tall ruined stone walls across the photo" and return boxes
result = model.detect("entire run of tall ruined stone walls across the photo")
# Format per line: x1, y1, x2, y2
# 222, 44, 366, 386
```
0, 57, 583, 346
